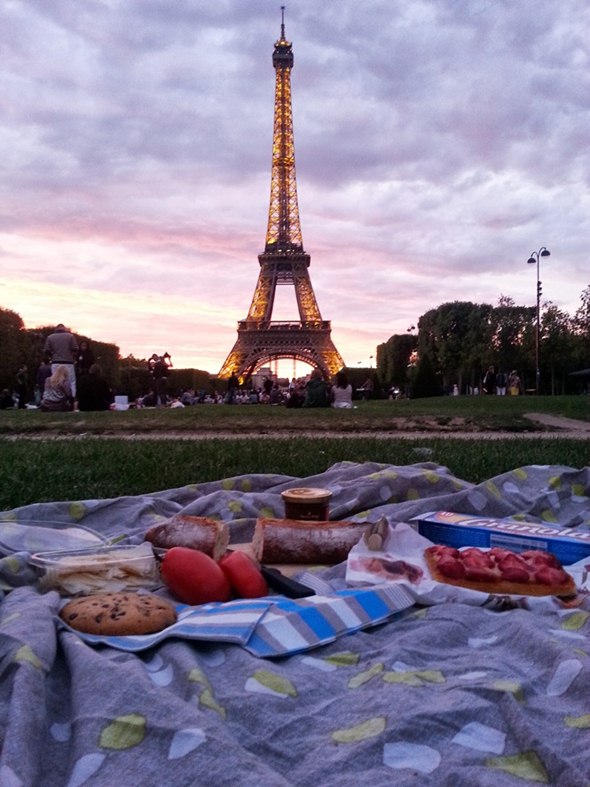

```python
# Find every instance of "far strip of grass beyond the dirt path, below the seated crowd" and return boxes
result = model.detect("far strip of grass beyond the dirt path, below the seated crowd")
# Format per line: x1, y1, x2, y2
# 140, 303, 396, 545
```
0, 396, 590, 436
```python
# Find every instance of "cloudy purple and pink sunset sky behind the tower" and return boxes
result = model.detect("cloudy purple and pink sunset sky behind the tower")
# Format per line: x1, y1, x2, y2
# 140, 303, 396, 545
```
0, 0, 590, 373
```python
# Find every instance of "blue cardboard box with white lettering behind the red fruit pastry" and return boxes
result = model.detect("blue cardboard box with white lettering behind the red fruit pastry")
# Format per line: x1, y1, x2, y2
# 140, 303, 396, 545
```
410, 511, 590, 566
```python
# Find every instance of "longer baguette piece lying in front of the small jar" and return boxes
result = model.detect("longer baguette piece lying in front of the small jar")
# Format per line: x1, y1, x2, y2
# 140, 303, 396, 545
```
252, 518, 366, 565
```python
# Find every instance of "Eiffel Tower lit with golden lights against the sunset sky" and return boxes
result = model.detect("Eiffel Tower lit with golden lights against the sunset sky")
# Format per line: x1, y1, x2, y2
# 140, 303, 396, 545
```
218, 6, 344, 379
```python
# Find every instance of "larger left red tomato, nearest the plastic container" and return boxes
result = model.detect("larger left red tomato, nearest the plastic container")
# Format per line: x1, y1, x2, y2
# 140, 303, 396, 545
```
160, 547, 231, 604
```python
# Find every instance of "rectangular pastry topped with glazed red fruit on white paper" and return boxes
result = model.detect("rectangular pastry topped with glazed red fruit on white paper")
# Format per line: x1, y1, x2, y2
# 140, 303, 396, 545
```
424, 545, 577, 596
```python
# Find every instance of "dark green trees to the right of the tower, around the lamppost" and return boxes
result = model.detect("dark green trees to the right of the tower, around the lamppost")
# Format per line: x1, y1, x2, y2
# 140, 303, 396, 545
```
377, 285, 590, 397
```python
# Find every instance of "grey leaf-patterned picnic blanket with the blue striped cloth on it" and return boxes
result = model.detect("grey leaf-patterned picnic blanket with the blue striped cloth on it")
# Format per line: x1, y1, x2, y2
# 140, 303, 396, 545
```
0, 462, 590, 787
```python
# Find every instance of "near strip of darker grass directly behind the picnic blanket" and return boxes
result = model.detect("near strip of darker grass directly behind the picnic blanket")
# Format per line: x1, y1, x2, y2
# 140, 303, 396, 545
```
0, 436, 590, 510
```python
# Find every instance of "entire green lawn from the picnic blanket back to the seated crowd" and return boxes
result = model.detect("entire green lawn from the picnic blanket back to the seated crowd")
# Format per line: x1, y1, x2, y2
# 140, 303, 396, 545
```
0, 396, 590, 510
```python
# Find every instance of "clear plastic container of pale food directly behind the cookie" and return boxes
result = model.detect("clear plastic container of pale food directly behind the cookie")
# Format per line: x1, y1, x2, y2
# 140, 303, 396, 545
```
29, 543, 161, 596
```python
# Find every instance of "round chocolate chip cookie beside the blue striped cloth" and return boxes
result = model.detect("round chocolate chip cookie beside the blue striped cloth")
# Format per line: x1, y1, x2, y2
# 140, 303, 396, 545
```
59, 593, 176, 636
